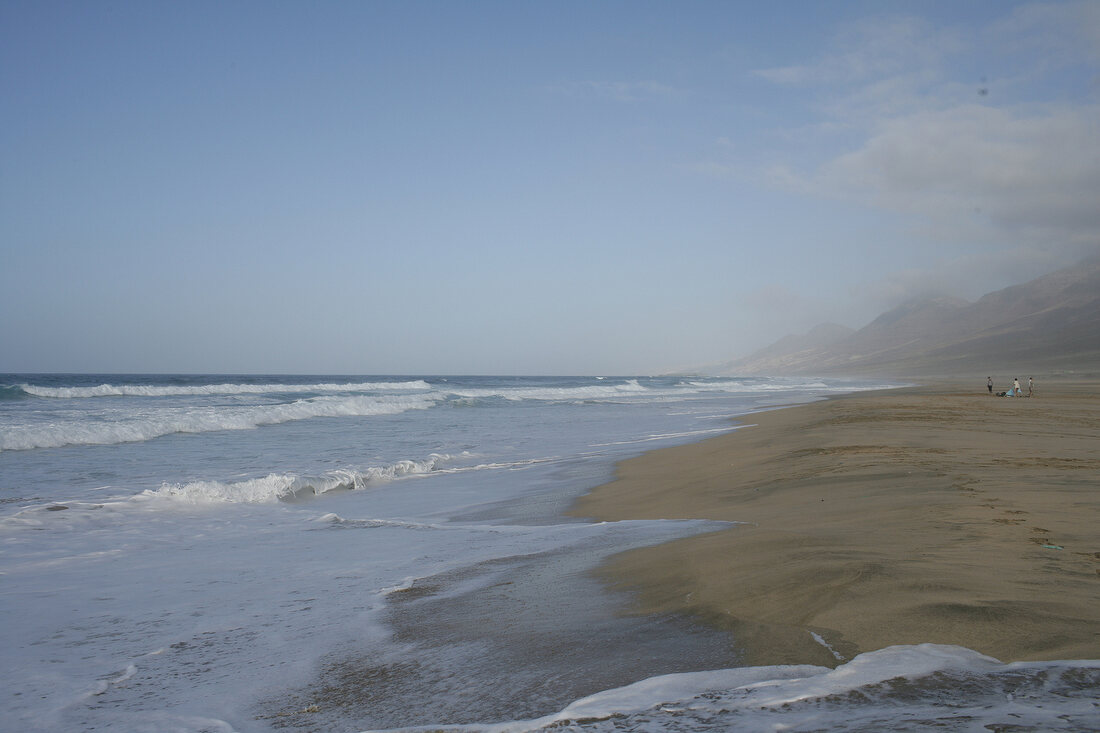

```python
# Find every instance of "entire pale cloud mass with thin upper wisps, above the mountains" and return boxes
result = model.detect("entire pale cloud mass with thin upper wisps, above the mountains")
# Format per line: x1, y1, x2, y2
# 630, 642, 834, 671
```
757, 2, 1100, 265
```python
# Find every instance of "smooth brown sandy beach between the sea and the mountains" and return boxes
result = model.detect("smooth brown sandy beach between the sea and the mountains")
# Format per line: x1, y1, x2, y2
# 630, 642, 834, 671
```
573, 379, 1100, 664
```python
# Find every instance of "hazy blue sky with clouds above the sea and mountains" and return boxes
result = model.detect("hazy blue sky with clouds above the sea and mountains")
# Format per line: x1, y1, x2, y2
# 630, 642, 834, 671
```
0, 0, 1100, 374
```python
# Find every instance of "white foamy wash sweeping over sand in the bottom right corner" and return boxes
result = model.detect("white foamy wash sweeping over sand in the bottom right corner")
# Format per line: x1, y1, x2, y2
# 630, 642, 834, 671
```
363, 644, 1100, 733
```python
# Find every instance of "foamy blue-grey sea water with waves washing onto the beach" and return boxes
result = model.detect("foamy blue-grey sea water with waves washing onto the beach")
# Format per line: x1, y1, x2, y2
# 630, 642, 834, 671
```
0, 374, 1100, 733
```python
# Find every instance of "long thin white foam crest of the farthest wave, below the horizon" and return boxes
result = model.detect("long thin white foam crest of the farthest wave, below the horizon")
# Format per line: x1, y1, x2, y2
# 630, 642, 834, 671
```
19, 380, 431, 400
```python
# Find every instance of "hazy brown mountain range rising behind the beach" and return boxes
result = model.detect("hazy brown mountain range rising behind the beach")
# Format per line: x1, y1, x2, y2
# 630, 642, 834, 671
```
716, 260, 1100, 376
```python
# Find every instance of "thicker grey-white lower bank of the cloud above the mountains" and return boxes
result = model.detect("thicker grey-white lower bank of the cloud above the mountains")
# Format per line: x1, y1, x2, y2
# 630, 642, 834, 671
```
818, 105, 1100, 243
